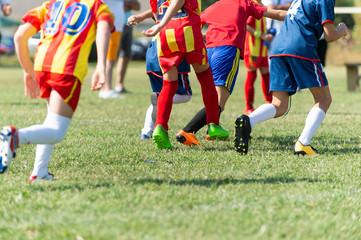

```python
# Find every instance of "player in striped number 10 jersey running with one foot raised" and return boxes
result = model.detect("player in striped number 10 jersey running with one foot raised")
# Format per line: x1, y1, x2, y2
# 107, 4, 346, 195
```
0, 0, 114, 182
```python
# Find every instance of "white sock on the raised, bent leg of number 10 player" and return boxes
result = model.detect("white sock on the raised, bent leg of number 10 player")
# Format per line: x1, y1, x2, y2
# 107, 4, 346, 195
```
18, 112, 71, 144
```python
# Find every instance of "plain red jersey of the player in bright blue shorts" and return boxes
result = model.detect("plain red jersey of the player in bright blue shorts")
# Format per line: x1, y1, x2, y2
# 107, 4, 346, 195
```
201, 0, 266, 59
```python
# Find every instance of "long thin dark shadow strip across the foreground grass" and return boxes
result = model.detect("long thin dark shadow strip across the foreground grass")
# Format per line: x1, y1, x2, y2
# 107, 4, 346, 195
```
130, 177, 331, 187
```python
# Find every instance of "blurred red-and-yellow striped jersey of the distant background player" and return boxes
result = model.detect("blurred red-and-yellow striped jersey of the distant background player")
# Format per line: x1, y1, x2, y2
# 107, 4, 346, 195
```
244, 17, 267, 57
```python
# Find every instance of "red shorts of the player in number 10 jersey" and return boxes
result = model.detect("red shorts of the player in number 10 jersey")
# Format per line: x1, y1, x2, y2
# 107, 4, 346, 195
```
35, 71, 81, 111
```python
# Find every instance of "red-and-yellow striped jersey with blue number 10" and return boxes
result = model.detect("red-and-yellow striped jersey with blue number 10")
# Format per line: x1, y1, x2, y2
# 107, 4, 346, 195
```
23, 0, 114, 82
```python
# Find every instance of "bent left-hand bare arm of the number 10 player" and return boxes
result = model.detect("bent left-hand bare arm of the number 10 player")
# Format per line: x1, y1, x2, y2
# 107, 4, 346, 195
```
14, 23, 40, 99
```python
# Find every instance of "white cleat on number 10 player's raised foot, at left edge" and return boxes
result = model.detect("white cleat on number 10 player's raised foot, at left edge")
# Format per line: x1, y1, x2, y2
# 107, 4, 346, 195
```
0, 126, 19, 174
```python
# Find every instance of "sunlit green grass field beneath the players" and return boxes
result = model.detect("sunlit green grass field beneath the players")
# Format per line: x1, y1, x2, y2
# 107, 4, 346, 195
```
0, 59, 361, 240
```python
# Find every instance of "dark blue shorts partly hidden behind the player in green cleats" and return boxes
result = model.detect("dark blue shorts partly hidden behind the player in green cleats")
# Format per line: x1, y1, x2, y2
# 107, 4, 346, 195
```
147, 72, 192, 95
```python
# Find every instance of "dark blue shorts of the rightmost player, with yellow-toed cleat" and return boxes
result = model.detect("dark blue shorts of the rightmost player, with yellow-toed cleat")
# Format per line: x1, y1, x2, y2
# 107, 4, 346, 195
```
270, 56, 328, 95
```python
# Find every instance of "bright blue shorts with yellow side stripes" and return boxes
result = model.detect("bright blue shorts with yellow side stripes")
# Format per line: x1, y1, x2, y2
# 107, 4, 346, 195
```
207, 46, 240, 93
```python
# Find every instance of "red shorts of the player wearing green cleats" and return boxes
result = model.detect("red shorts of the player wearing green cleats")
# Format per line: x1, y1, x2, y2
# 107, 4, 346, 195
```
159, 48, 208, 73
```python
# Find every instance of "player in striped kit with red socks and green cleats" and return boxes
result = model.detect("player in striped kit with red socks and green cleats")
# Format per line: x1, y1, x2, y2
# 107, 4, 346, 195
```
139, 0, 229, 149
